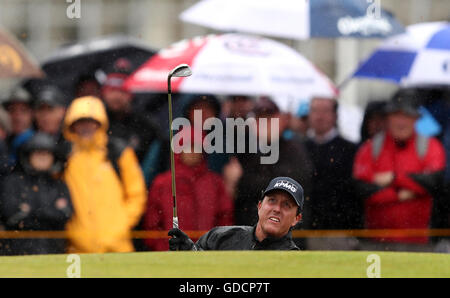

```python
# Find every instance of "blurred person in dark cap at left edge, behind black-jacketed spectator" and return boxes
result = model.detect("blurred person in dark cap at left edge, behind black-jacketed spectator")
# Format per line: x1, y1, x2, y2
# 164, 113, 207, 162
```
3, 87, 34, 168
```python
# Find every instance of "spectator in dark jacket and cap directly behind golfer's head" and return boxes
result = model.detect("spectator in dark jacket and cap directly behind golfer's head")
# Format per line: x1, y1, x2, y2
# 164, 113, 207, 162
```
235, 98, 312, 226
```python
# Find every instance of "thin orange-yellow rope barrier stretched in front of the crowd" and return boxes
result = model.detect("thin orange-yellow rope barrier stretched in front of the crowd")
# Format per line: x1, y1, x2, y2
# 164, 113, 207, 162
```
0, 229, 450, 239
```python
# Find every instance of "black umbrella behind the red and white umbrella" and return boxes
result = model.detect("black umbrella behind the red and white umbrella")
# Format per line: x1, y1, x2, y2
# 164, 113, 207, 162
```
42, 35, 156, 97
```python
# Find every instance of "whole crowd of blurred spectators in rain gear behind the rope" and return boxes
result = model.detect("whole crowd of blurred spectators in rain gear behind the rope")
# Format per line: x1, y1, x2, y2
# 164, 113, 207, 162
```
0, 59, 450, 255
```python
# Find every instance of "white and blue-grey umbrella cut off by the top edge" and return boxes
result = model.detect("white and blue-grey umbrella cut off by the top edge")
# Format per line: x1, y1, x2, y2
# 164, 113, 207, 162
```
180, 0, 404, 39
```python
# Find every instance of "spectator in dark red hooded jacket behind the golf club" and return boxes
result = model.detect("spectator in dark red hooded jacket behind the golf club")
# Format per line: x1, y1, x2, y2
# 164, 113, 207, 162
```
144, 128, 233, 250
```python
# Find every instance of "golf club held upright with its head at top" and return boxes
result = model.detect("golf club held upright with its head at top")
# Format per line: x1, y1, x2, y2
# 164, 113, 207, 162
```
167, 64, 192, 228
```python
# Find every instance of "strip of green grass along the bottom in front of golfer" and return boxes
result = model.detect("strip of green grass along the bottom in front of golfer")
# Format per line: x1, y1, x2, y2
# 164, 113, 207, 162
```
0, 251, 450, 278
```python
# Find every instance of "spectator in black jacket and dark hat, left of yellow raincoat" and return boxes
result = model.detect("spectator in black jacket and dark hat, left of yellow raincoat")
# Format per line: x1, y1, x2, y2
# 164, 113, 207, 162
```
0, 133, 72, 255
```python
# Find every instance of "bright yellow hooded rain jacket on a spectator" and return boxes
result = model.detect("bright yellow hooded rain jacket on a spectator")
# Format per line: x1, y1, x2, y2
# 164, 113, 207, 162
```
64, 96, 146, 253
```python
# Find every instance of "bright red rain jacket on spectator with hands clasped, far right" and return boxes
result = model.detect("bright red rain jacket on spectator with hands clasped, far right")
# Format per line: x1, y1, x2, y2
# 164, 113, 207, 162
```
353, 134, 445, 243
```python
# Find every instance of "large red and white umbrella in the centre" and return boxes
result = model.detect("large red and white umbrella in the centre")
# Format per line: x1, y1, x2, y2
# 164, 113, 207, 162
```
125, 33, 337, 107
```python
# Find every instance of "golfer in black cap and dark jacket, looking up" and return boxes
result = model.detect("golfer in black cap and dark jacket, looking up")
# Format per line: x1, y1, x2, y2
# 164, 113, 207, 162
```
169, 177, 304, 250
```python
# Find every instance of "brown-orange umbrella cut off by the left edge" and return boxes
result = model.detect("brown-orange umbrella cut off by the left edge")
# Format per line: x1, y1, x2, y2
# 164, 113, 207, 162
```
0, 28, 44, 78
